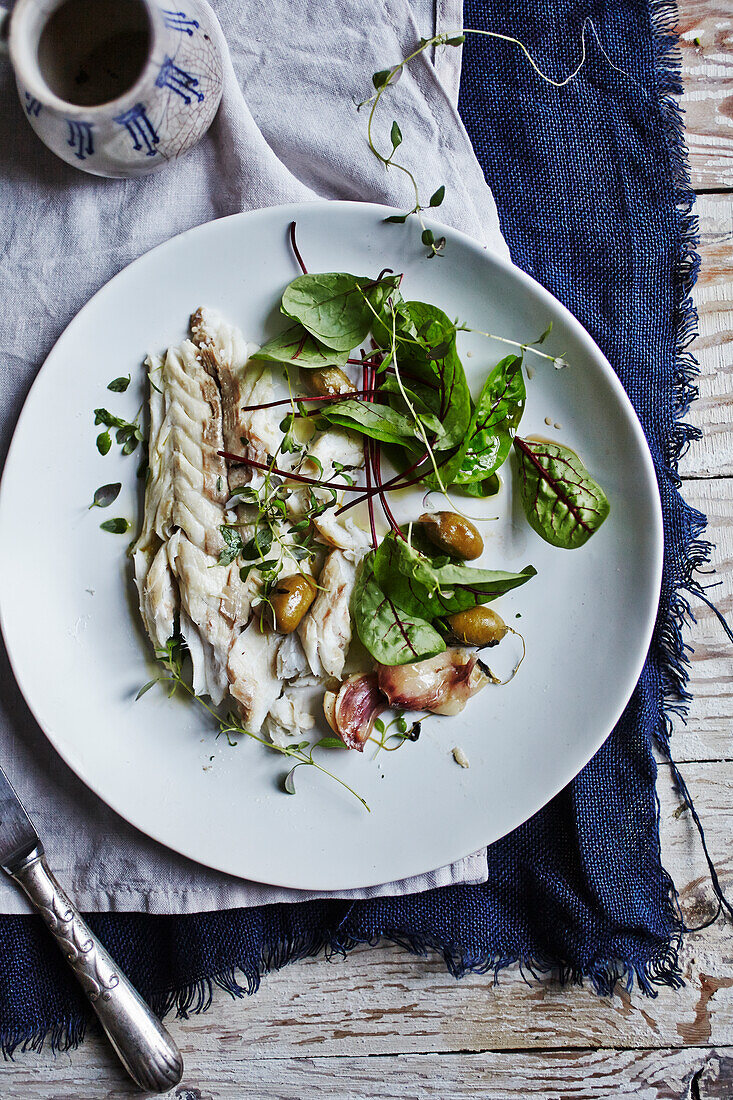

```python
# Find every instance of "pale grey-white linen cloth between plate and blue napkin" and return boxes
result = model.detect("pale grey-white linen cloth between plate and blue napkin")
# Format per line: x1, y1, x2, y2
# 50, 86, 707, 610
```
0, 0, 507, 913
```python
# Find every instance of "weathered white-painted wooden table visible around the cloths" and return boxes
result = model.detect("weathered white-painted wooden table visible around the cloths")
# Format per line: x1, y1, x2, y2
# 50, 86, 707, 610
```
5, 8, 733, 1100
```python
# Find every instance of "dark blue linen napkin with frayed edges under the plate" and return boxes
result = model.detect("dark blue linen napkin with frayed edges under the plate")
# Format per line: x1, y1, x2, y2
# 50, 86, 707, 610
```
0, 0, 708, 1051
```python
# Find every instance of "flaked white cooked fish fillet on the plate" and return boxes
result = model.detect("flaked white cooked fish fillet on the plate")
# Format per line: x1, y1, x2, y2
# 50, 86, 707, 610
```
132, 307, 370, 744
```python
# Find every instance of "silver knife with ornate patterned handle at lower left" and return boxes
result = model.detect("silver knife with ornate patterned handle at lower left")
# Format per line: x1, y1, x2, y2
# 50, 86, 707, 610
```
0, 768, 183, 1092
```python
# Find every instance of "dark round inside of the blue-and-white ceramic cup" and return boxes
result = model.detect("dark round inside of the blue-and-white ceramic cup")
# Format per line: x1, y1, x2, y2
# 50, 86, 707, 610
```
39, 0, 151, 107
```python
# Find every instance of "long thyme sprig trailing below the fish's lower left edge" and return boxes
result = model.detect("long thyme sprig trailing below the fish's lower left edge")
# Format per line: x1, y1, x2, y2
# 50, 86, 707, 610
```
135, 637, 371, 813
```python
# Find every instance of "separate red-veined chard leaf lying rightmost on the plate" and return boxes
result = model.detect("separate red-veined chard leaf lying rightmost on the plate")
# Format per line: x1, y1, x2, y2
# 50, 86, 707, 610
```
514, 436, 610, 550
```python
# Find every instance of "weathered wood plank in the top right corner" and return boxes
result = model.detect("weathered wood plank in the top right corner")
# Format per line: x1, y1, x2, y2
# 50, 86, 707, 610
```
677, 0, 733, 191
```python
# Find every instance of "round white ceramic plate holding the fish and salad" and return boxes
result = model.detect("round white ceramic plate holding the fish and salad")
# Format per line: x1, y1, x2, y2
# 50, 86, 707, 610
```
0, 202, 663, 889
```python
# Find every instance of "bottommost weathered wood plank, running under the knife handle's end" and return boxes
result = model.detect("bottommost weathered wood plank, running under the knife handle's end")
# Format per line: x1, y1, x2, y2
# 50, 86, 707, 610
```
2, 1043, 733, 1100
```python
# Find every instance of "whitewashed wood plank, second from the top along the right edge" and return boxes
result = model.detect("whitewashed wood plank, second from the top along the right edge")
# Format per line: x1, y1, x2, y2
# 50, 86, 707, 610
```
680, 195, 733, 477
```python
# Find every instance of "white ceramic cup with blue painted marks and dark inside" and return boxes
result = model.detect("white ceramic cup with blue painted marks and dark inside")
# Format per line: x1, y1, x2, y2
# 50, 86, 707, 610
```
0, 0, 226, 177
